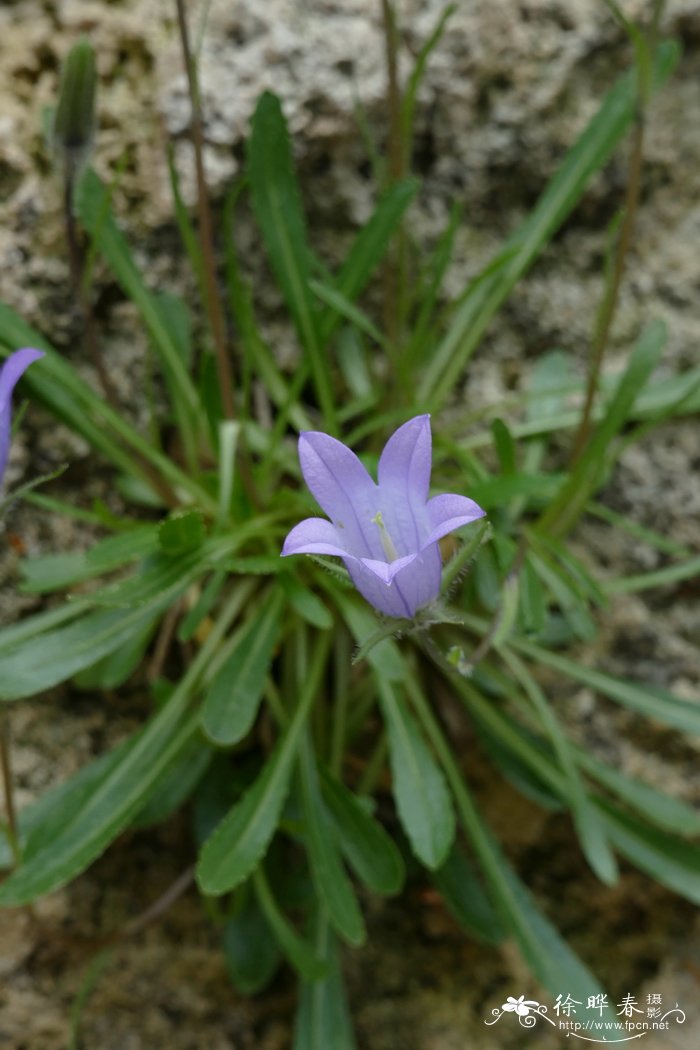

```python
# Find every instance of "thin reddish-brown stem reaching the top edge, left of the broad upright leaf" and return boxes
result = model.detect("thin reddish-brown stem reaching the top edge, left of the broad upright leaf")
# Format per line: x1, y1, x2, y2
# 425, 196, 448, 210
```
175, 0, 235, 419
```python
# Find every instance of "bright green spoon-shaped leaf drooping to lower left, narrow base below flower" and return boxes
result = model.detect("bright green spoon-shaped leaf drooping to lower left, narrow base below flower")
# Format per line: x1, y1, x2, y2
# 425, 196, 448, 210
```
197, 639, 327, 895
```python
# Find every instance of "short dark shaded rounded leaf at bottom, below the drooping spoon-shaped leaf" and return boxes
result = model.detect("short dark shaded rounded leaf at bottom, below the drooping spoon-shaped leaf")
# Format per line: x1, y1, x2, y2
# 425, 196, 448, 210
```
221, 894, 279, 995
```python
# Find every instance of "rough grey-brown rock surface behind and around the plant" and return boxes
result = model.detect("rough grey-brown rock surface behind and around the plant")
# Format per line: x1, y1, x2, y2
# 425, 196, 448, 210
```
0, 0, 700, 1050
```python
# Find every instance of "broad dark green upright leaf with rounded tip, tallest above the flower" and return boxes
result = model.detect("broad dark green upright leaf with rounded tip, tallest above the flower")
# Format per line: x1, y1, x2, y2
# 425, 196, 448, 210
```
248, 91, 335, 429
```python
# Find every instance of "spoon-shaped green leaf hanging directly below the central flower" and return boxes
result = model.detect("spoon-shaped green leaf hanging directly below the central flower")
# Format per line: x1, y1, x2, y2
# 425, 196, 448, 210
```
377, 676, 454, 868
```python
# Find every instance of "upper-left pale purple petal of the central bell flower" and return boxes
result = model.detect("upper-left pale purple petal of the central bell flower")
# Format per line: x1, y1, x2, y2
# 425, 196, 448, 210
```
299, 431, 383, 561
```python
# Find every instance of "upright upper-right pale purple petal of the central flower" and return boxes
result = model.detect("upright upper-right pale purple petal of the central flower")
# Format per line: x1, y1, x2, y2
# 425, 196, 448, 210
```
379, 416, 432, 554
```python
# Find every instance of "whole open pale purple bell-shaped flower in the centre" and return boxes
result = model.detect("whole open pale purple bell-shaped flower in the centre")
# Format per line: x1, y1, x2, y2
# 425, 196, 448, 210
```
282, 416, 484, 616
